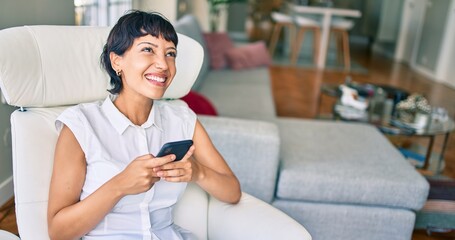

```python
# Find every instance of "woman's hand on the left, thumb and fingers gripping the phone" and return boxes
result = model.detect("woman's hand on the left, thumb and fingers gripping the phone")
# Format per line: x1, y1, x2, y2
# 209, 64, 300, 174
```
112, 154, 178, 195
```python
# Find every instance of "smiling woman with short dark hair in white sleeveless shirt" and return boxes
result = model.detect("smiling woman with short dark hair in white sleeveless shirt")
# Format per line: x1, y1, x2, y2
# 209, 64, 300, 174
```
48, 11, 241, 240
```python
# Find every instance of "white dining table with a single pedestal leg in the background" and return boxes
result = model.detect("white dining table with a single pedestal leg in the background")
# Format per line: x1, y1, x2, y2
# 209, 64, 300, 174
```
289, 4, 362, 69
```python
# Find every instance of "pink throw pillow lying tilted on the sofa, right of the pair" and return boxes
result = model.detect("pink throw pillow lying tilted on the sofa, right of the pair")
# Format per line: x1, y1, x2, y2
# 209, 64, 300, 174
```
226, 41, 272, 70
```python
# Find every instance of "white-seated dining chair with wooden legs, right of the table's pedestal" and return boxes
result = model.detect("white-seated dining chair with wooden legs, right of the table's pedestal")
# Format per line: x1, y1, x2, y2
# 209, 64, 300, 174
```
330, 18, 354, 71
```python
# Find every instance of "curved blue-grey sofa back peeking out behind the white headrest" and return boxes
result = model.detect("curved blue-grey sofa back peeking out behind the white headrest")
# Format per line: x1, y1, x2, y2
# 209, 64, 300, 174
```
174, 15, 210, 90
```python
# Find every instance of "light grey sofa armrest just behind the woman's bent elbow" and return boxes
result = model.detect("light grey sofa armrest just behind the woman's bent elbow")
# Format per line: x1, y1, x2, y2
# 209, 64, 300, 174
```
199, 116, 280, 203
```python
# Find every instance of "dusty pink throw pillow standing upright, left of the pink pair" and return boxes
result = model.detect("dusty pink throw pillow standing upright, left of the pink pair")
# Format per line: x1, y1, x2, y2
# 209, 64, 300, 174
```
203, 33, 234, 69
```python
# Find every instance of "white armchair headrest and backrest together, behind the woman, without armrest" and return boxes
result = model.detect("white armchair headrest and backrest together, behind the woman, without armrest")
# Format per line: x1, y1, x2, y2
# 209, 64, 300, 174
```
0, 26, 206, 239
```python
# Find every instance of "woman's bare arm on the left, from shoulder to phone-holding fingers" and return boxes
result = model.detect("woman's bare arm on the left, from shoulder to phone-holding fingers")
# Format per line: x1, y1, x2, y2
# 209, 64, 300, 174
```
47, 126, 172, 239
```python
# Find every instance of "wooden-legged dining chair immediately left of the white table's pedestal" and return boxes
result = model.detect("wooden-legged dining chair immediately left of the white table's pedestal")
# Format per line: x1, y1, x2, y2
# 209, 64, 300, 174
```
291, 15, 321, 65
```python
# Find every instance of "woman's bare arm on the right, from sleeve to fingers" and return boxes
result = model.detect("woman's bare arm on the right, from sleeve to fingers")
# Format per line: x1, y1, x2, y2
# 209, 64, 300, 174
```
157, 120, 241, 203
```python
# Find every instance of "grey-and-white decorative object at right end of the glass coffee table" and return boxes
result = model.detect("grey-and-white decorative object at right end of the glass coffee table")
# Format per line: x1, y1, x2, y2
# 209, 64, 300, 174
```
396, 93, 431, 129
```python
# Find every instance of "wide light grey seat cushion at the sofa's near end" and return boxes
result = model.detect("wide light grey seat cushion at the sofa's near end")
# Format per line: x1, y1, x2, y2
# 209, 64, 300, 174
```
277, 118, 429, 210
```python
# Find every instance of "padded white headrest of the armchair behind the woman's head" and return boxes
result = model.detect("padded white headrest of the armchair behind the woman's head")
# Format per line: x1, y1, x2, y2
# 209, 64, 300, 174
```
0, 26, 204, 107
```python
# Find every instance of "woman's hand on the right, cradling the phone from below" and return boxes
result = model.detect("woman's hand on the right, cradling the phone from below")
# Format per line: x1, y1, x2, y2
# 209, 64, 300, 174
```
153, 146, 201, 182
